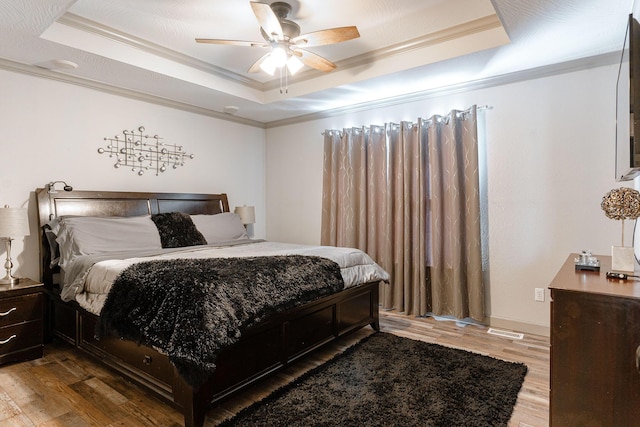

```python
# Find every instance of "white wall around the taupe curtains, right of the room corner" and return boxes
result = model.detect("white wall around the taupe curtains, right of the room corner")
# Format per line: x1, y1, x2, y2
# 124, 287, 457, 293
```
266, 66, 632, 333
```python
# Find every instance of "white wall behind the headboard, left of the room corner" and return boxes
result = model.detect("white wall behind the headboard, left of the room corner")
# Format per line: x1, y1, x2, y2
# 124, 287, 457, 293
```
0, 70, 265, 279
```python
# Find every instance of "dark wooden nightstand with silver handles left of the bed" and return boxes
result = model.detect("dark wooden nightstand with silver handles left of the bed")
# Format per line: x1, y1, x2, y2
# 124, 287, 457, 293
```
0, 279, 45, 364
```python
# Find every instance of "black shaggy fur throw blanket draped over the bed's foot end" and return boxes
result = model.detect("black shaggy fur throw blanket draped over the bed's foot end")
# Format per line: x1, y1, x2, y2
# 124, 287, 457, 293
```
96, 255, 344, 388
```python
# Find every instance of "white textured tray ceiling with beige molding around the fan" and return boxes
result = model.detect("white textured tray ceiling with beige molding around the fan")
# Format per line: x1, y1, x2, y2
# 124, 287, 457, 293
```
0, 0, 632, 124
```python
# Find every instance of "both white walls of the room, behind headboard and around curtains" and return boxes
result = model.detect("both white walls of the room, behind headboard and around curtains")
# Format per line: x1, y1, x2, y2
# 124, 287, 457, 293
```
0, 61, 632, 336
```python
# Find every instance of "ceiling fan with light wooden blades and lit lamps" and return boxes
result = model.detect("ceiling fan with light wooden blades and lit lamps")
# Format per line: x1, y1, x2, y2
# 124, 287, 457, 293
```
196, 1, 360, 75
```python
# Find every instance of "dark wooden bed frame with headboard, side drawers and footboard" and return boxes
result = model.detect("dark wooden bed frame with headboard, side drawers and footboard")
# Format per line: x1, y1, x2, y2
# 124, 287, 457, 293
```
36, 188, 379, 427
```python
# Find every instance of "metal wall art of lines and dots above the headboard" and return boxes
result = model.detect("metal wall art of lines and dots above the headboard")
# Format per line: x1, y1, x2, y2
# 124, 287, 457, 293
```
98, 126, 194, 175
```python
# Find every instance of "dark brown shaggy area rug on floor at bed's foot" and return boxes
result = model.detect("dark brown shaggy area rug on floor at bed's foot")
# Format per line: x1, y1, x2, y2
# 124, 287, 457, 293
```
222, 332, 527, 427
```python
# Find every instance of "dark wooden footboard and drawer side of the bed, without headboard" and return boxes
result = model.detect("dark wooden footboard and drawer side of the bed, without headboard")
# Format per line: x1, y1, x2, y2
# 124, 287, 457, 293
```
49, 282, 379, 427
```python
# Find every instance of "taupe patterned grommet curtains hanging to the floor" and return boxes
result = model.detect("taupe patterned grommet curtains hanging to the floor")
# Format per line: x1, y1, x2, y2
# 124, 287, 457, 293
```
321, 106, 484, 321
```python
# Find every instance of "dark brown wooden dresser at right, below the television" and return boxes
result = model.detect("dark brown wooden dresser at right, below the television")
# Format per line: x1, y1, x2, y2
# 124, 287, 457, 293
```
549, 254, 640, 427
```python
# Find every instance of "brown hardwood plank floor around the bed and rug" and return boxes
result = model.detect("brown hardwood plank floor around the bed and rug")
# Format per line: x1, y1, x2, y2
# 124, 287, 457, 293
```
0, 312, 549, 427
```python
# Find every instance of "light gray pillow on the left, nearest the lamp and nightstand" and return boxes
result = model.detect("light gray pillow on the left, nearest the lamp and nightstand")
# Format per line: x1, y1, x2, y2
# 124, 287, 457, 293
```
54, 215, 162, 268
